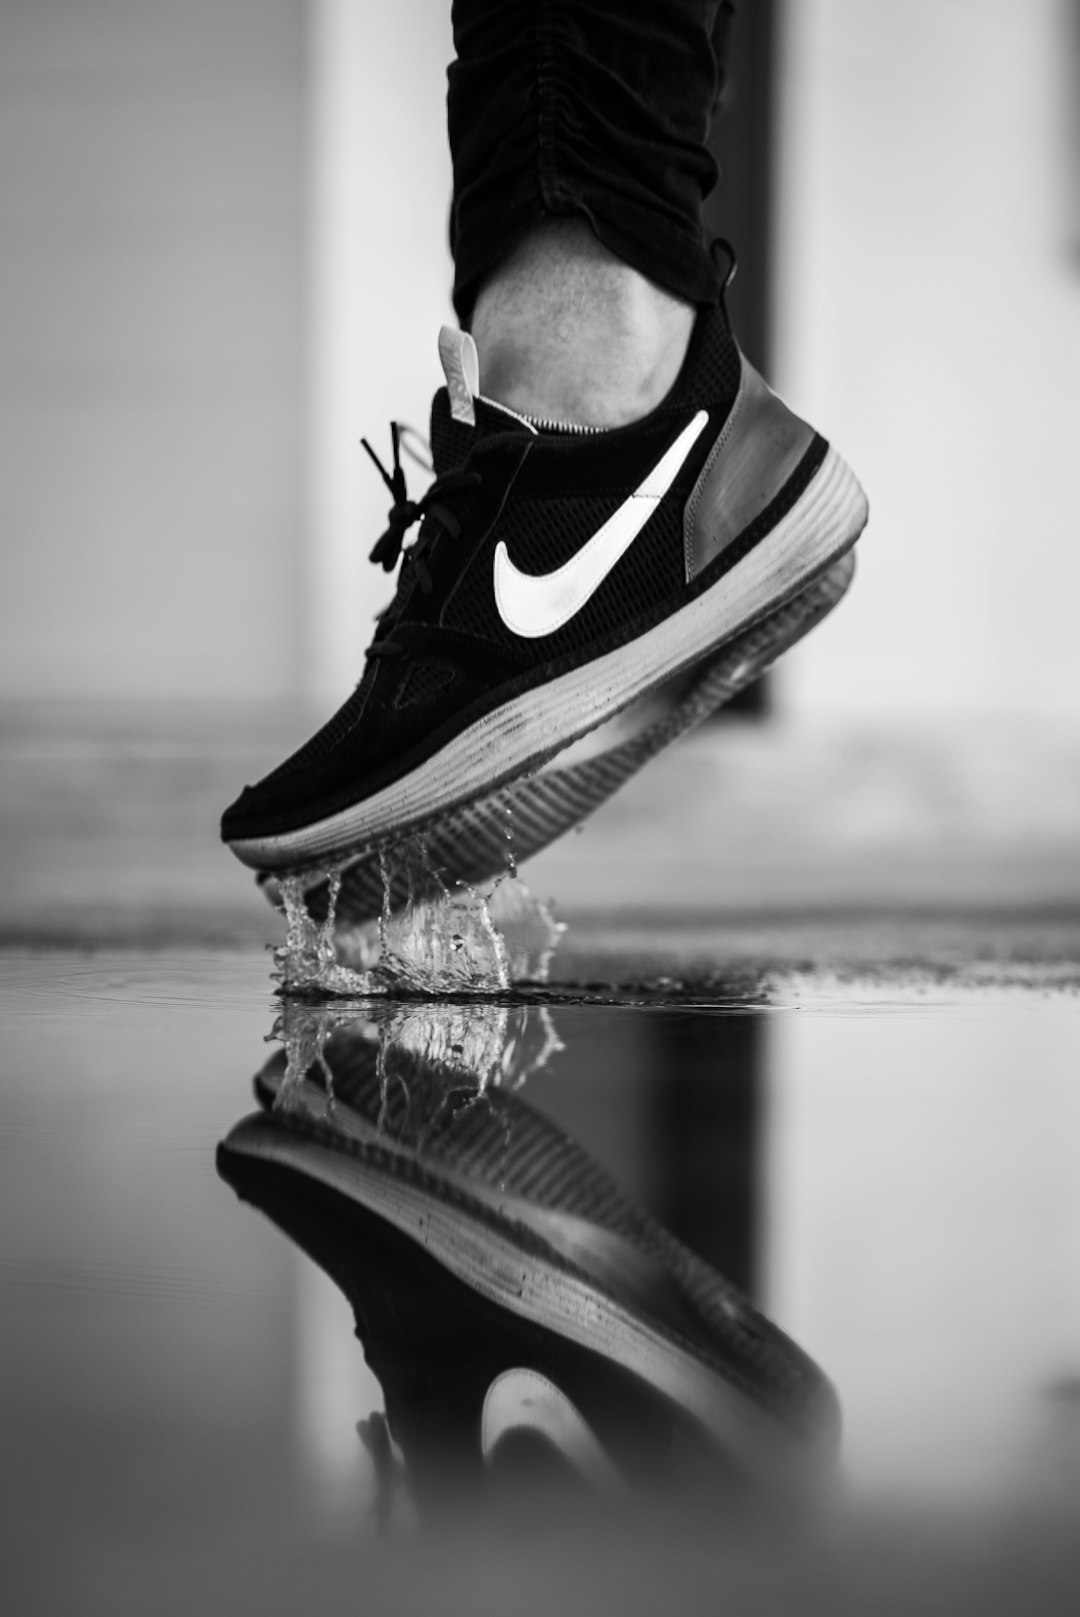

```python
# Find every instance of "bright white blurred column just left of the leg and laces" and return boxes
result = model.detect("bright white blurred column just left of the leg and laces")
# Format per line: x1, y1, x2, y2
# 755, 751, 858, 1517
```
306, 0, 453, 702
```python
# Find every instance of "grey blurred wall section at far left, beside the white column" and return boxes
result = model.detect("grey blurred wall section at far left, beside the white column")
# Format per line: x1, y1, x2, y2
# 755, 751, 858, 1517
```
0, 0, 309, 699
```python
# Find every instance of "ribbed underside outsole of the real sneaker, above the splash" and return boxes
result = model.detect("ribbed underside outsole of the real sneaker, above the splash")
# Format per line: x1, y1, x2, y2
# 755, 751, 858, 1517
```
260, 555, 855, 927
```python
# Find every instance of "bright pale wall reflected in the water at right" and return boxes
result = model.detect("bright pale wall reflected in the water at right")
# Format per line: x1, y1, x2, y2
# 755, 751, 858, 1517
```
761, 985, 1080, 1501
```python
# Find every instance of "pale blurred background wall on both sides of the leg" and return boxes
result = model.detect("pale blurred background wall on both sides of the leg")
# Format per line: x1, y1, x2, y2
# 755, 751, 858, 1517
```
0, 0, 1080, 718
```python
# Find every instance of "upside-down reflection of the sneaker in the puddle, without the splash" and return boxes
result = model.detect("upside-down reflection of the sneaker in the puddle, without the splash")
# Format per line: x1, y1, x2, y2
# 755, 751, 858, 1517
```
220, 1028, 836, 1476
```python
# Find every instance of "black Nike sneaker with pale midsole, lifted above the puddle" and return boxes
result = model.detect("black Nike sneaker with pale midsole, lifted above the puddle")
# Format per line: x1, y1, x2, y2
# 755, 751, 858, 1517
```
221, 309, 867, 870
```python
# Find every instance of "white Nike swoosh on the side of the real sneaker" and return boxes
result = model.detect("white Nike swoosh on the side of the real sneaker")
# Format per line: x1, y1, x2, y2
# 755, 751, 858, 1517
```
495, 409, 708, 640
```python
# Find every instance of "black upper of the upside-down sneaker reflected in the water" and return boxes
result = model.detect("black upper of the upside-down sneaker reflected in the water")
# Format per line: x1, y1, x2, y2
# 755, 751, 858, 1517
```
218, 1116, 646, 1509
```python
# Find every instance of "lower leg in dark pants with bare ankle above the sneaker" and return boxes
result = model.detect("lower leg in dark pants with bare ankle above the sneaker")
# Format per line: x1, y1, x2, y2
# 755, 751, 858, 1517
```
449, 0, 728, 427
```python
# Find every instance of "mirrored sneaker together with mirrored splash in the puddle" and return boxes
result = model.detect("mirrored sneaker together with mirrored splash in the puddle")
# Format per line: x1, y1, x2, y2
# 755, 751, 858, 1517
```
218, 1001, 837, 1515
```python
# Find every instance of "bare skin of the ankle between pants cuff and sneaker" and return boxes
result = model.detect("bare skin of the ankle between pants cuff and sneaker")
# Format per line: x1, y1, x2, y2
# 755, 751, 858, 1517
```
472, 220, 695, 427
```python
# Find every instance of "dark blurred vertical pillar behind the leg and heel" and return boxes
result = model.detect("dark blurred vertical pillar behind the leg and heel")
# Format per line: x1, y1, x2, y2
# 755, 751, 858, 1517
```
705, 0, 778, 716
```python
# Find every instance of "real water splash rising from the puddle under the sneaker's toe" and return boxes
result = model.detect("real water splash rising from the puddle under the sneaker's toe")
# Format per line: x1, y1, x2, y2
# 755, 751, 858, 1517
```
275, 817, 566, 998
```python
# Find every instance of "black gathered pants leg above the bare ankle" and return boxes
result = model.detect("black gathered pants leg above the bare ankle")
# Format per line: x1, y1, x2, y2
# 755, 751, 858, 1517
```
446, 0, 732, 322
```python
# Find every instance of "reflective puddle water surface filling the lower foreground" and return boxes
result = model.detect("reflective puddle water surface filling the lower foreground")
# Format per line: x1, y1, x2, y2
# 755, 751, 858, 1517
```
0, 952, 1080, 1614
